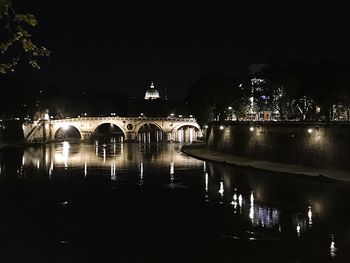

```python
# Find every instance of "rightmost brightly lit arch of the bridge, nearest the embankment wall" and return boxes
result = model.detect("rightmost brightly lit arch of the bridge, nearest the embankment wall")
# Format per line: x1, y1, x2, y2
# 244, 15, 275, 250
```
171, 123, 202, 142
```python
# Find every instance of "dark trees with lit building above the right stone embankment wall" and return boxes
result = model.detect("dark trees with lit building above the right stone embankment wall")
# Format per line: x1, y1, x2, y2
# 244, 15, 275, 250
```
187, 60, 350, 124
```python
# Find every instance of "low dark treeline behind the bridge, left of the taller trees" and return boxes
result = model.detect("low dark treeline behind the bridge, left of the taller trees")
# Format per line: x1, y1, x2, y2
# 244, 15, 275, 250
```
0, 75, 189, 120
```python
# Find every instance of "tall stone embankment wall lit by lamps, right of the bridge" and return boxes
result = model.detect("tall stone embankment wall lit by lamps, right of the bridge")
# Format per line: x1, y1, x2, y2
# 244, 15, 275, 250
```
207, 122, 350, 169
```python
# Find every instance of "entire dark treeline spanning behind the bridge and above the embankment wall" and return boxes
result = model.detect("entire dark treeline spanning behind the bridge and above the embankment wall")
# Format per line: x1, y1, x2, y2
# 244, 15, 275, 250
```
0, 60, 350, 125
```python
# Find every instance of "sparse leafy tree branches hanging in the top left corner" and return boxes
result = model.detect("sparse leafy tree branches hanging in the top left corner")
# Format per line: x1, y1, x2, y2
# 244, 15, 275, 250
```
0, 0, 50, 74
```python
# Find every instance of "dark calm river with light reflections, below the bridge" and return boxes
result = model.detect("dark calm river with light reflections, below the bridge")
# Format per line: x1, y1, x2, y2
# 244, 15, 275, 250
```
0, 138, 350, 262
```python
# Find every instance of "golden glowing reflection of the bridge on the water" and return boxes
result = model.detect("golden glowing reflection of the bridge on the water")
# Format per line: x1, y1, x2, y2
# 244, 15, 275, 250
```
19, 140, 203, 180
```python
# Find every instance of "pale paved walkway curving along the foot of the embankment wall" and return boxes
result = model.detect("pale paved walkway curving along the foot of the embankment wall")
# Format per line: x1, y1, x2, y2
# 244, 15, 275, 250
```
181, 143, 350, 182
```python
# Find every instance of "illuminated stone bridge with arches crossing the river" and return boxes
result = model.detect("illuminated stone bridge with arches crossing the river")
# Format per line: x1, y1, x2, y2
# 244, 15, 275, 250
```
23, 116, 202, 142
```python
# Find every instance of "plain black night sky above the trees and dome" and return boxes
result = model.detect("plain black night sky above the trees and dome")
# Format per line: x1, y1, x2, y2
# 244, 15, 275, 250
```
14, 0, 350, 98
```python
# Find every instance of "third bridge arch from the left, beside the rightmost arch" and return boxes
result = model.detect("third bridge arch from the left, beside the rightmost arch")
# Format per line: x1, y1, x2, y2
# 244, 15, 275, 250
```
135, 121, 164, 143
